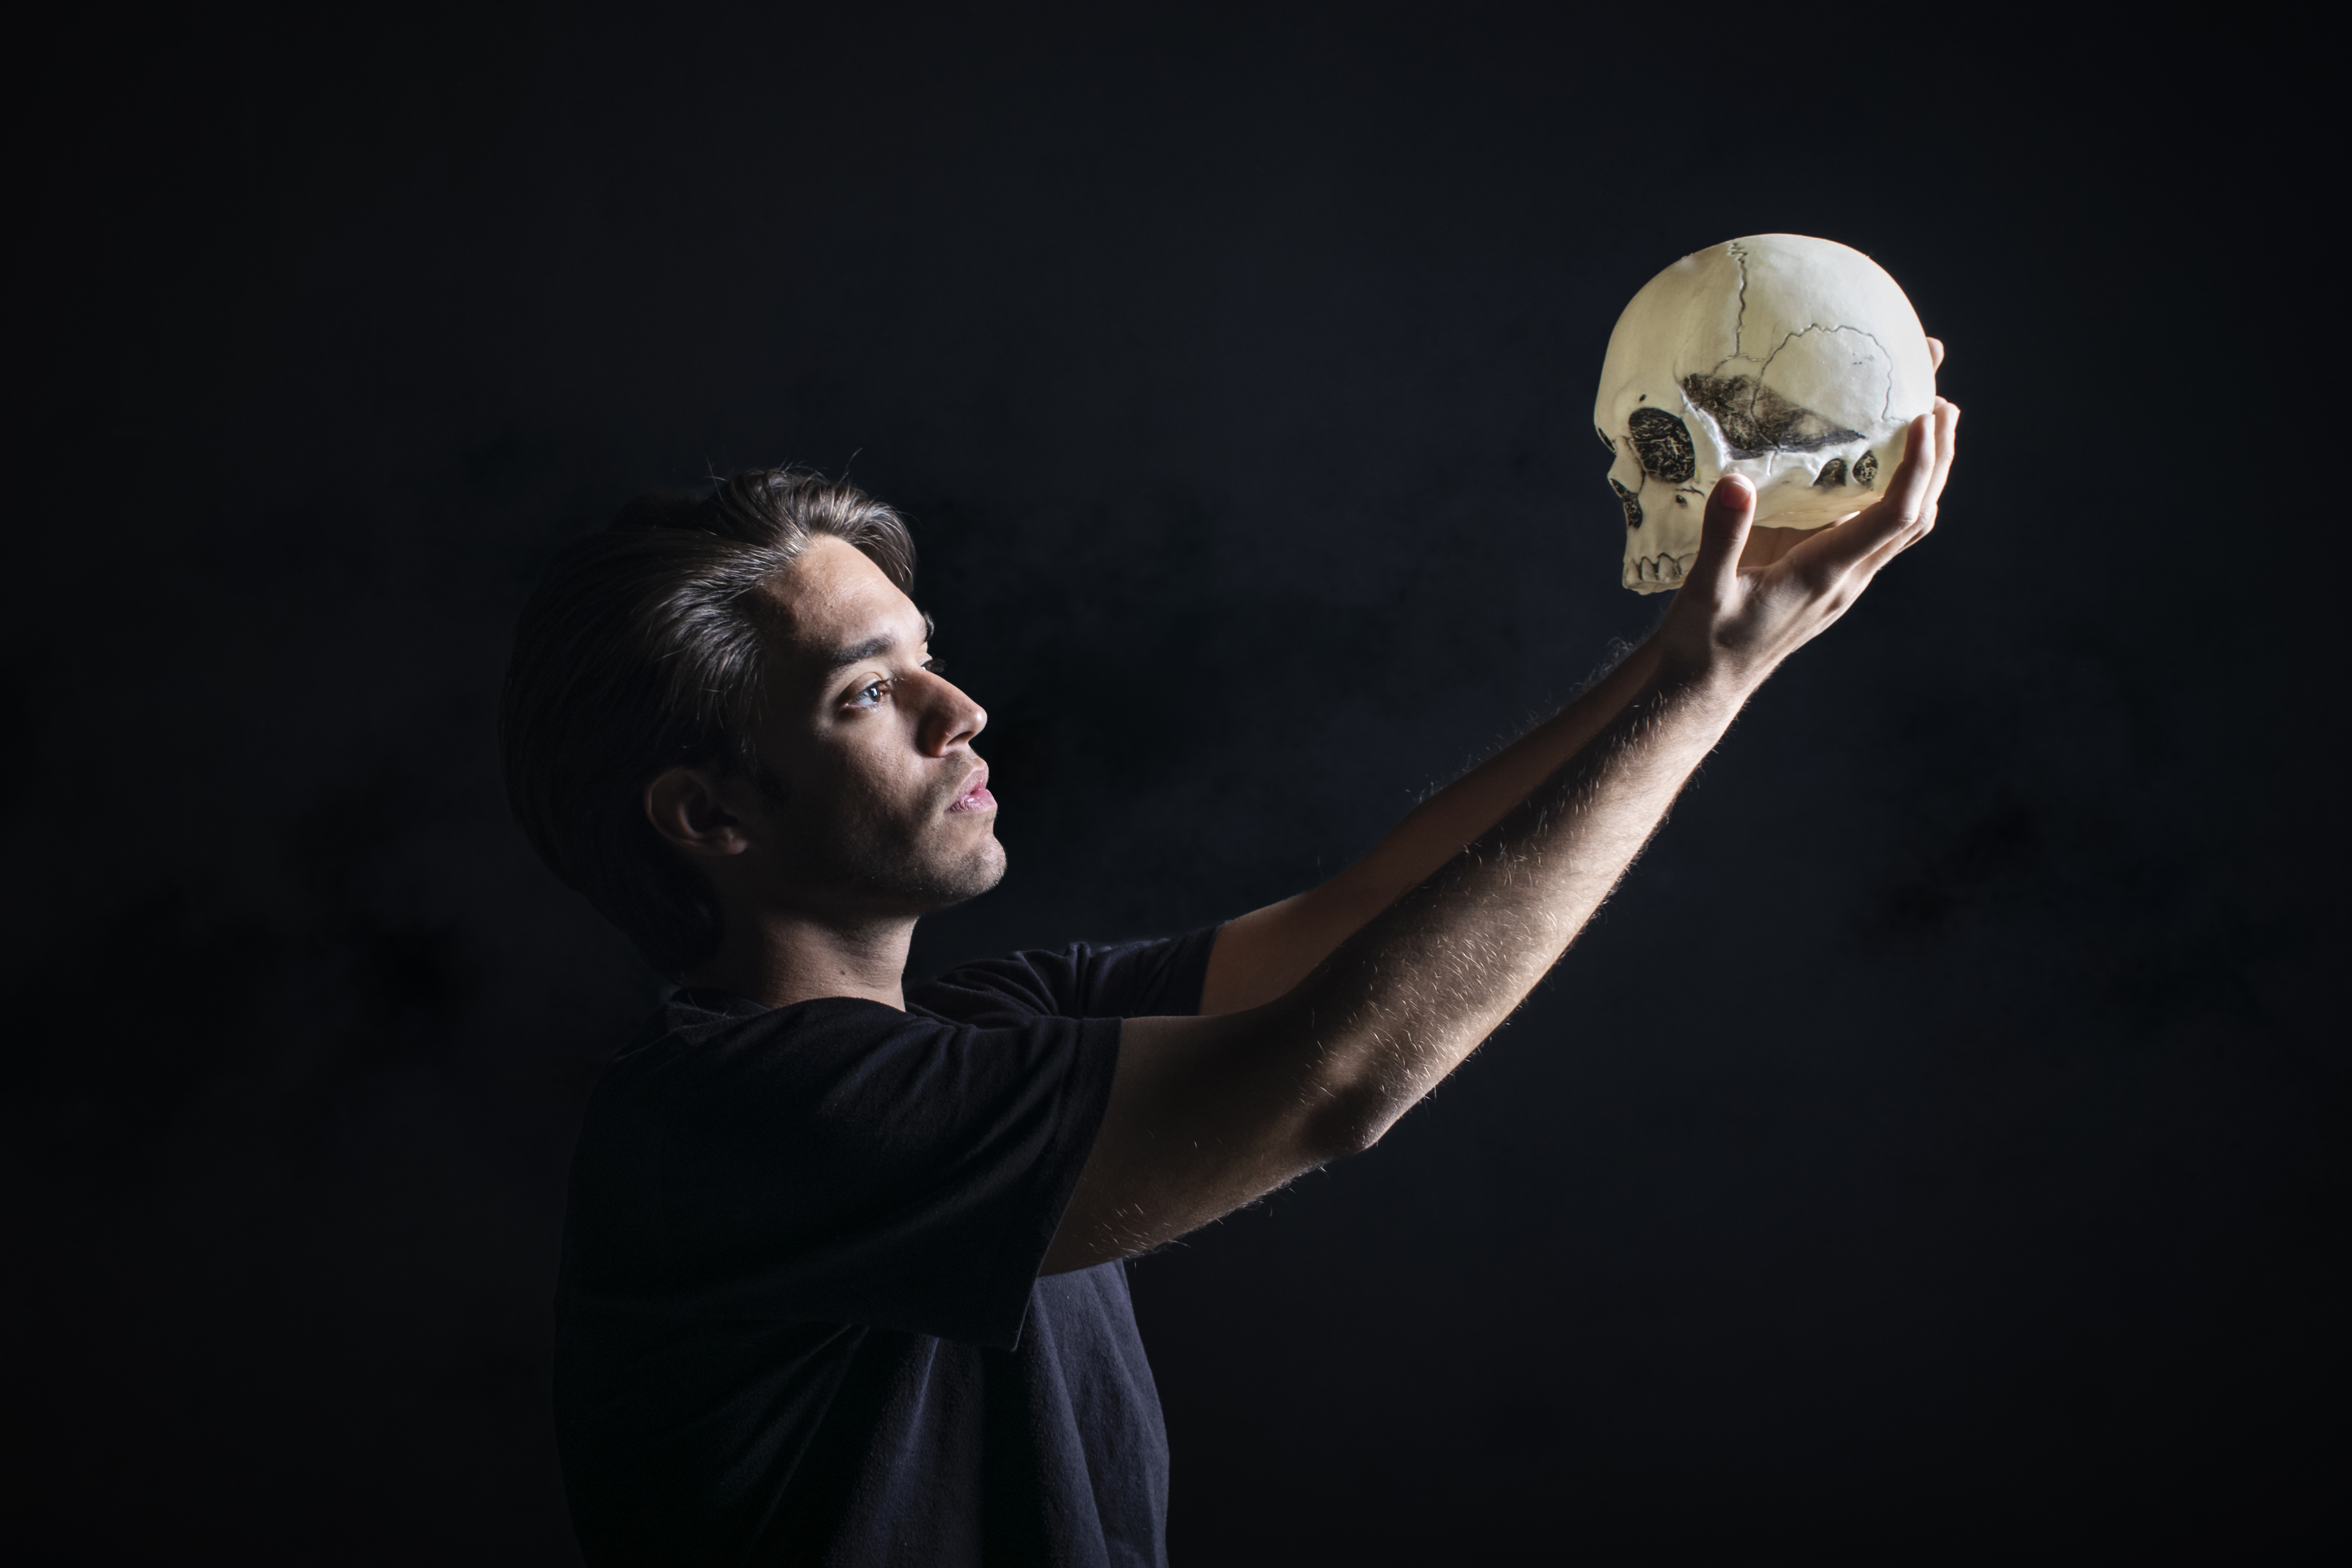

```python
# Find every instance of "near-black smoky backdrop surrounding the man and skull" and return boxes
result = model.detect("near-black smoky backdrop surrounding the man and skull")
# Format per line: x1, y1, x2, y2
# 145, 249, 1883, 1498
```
0, 7, 2347, 1563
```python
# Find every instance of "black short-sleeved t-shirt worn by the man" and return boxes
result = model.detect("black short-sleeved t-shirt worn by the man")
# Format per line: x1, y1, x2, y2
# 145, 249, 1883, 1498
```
555, 931, 1216, 1568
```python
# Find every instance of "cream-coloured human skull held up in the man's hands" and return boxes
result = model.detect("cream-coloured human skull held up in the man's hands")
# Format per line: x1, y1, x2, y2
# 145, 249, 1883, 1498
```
1592, 235, 1936, 592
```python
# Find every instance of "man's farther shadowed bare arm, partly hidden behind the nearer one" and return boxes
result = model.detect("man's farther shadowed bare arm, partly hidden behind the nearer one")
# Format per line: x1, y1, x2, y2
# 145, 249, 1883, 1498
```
1202, 642, 1658, 1013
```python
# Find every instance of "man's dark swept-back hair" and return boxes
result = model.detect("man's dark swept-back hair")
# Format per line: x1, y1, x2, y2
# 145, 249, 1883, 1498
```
499, 468, 915, 980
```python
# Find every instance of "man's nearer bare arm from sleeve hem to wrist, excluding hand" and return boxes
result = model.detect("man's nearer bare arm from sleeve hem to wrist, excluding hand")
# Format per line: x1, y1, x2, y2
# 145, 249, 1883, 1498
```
1044, 663, 1740, 1274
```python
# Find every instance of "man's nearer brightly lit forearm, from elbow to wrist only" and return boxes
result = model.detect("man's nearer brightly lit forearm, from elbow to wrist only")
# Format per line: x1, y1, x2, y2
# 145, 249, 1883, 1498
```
1298, 658, 1748, 1152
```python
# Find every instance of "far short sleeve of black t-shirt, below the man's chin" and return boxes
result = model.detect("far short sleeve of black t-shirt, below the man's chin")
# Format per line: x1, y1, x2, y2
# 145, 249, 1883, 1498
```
908, 926, 1221, 1025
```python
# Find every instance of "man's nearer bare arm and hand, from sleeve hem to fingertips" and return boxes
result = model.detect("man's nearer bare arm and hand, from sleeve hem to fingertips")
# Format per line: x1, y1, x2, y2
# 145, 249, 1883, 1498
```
1044, 399, 1959, 1274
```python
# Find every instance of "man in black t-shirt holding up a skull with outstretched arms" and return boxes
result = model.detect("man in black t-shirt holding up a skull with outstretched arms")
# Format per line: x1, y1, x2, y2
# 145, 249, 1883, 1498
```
501, 383, 1957, 1566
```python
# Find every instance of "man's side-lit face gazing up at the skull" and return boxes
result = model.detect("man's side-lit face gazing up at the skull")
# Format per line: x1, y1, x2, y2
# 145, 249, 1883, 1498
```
757, 534, 1004, 917
